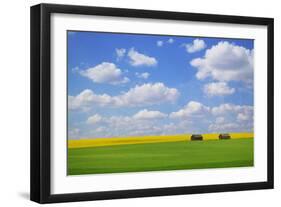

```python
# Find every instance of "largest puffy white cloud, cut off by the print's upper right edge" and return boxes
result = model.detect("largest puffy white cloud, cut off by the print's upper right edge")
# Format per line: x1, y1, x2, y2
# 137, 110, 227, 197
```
190, 41, 253, 83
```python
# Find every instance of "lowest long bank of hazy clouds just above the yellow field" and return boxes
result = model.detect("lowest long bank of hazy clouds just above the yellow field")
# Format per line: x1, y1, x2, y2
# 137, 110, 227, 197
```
76, 101, 253, 137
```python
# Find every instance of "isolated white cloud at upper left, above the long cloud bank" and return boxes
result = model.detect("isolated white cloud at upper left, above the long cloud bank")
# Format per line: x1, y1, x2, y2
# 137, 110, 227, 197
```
80, 62, 130, 85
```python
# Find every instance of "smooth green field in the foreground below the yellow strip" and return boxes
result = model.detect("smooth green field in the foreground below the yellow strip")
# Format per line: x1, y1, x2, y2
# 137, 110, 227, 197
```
68, 138, 254, 175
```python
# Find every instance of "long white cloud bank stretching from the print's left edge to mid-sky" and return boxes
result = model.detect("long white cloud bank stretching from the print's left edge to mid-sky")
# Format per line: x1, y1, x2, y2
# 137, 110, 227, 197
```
68, 83, 180, 110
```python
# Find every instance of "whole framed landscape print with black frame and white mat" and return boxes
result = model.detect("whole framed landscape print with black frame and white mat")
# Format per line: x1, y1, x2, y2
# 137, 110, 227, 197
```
31, 4, 273, 203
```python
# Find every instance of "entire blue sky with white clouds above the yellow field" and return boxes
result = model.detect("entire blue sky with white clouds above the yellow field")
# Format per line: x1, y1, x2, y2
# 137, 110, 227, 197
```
67, 32, 254, 139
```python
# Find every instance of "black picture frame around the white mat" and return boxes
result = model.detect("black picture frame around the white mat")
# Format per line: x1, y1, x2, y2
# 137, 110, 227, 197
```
30, 4, 274, 203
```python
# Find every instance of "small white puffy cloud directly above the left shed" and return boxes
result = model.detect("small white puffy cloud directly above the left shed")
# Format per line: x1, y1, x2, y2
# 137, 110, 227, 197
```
170, 101, 210, 118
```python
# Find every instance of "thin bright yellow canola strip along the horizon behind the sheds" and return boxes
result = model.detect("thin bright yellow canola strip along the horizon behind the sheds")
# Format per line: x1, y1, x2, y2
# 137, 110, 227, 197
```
68, 132, 254, 148
